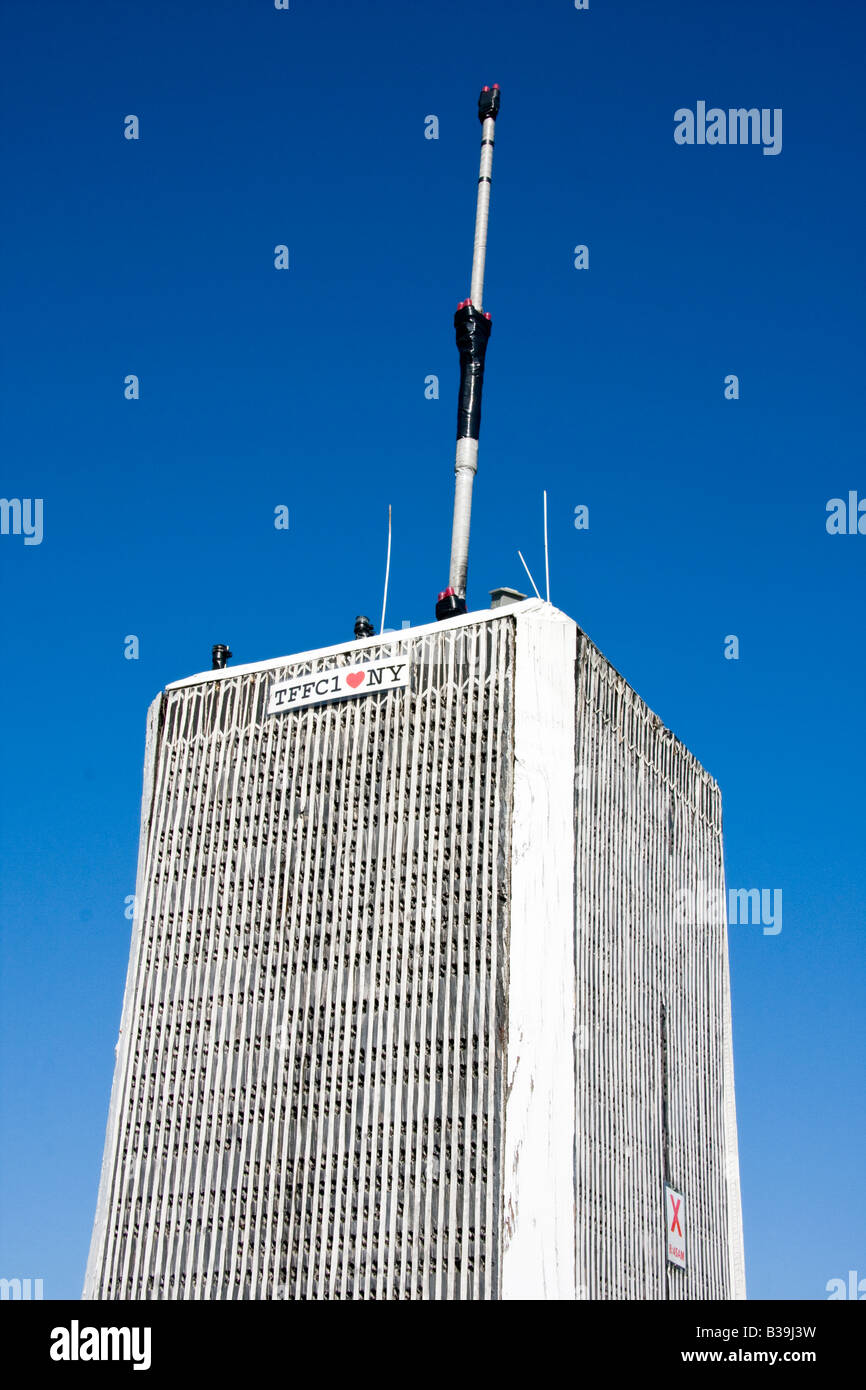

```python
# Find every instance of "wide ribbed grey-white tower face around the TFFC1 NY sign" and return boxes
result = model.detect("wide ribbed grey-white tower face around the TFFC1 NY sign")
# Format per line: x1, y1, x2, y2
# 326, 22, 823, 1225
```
88, 623, 514, 1298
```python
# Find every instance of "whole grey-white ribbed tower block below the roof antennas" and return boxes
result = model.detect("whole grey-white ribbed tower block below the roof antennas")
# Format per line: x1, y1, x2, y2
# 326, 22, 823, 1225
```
85, 599, 745, 1298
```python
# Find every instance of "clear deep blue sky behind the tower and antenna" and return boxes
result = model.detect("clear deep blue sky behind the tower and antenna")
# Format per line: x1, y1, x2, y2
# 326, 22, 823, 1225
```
0, 0, 866, 1298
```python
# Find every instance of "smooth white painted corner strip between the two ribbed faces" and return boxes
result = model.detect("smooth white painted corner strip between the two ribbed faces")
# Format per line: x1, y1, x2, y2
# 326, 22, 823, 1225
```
502, 605, 577, 1298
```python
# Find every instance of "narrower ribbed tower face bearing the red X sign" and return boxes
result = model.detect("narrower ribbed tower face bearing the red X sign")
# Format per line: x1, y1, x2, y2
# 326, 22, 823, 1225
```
575, 637, 744, 1298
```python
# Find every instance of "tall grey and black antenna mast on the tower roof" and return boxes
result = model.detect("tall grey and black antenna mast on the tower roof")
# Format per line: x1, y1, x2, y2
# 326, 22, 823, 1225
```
436, 82, 499, 619
